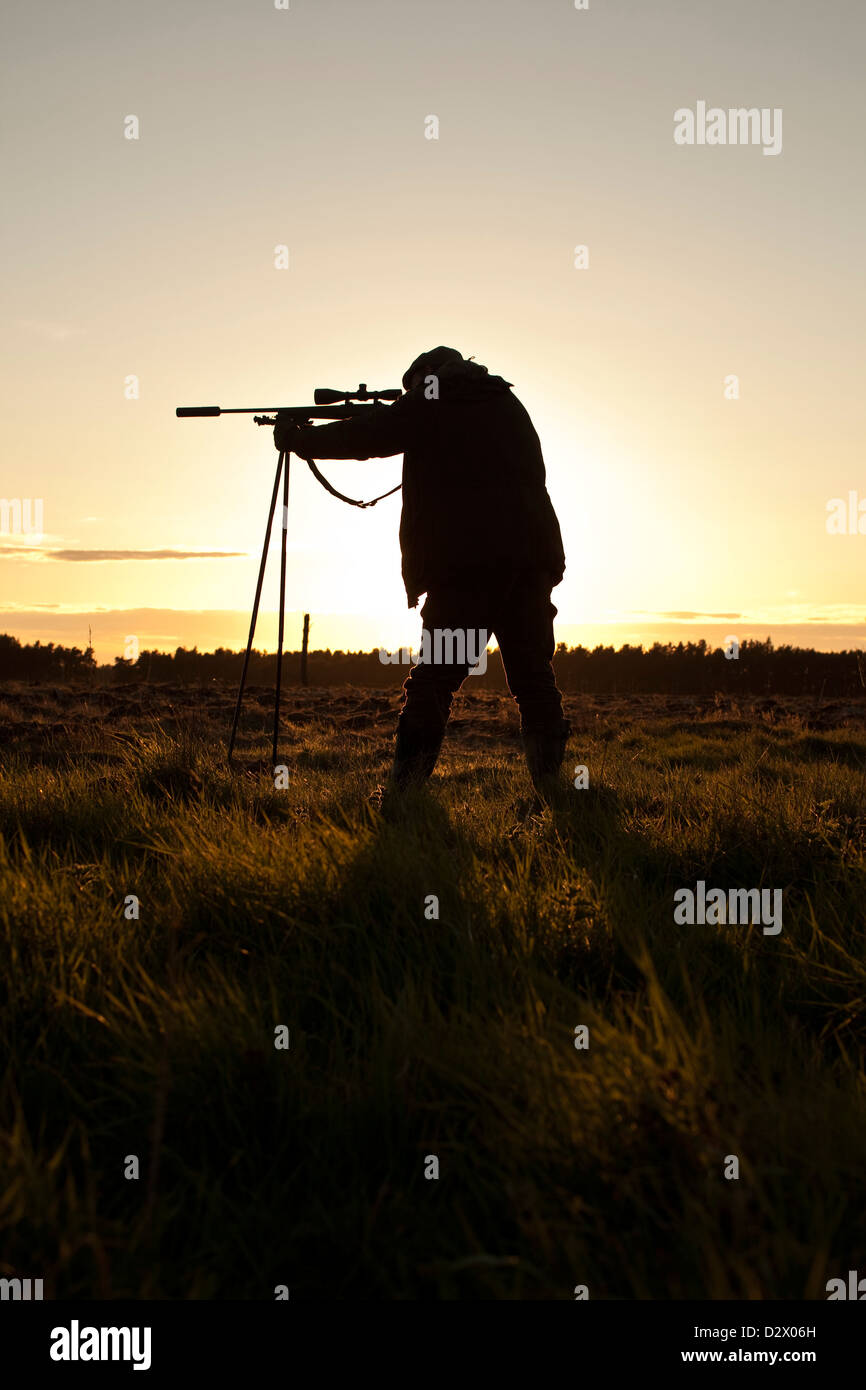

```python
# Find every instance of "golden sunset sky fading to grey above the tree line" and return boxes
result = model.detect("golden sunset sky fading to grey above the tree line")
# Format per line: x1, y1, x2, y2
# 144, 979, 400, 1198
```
0, 0, 866, 660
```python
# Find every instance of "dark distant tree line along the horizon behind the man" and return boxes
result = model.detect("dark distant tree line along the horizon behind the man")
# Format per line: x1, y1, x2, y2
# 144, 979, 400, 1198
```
0, 634, 866, 699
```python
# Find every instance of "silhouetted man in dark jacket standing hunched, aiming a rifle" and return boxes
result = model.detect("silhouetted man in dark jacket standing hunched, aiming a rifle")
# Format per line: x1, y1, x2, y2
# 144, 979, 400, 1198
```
274, 348, 570, 796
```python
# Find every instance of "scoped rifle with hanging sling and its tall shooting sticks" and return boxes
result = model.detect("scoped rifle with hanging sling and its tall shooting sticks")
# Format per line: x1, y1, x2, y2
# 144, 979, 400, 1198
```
175, 382, 402, 766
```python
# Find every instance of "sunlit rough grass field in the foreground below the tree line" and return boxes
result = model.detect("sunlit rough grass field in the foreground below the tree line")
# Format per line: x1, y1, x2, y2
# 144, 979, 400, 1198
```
0, 682, 866, 1300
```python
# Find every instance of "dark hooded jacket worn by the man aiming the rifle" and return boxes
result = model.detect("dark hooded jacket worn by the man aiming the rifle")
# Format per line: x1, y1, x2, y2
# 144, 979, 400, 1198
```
287, 357, 566, 607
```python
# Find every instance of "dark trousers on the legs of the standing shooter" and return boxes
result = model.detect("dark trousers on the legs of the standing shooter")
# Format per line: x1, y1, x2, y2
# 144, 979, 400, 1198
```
398, 570, 569, 749
